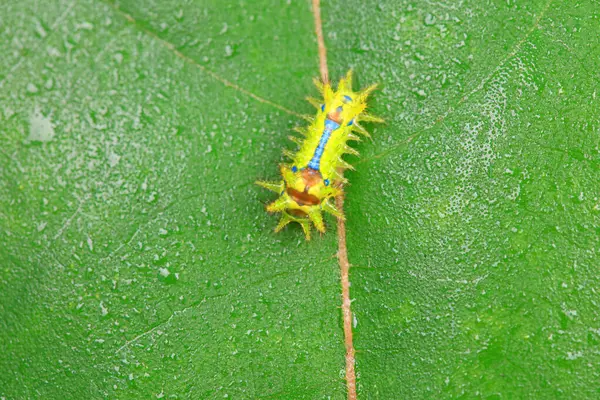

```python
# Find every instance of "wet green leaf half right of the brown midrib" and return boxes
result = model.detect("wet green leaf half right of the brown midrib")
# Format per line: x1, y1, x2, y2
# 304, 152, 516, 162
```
323, 1, 600, 399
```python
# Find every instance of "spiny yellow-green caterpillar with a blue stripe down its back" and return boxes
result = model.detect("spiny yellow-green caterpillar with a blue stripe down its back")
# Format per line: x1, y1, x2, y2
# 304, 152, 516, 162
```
256, 71, 383, 240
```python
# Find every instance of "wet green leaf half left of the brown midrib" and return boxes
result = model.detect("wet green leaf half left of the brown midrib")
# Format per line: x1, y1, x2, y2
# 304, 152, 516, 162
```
0, 1, 345, 399
